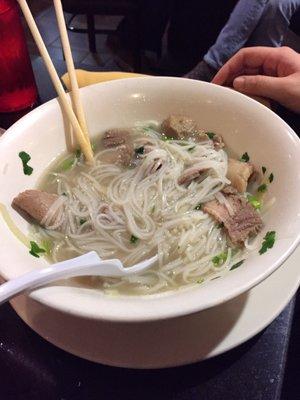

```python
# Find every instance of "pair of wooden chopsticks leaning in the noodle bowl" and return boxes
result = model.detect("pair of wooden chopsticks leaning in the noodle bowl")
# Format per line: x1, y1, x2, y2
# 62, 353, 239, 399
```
18, 0, 93, 163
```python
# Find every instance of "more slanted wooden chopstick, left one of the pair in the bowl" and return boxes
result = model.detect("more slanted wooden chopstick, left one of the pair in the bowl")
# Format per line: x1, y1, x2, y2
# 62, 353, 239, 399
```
18, 0, 94, 163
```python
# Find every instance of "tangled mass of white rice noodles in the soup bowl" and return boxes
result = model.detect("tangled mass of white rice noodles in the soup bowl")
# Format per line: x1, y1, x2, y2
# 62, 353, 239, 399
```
32, 121, 250, 294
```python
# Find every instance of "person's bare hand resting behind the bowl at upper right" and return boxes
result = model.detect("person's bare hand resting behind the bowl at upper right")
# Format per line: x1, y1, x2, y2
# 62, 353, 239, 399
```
212, 47, 300, 113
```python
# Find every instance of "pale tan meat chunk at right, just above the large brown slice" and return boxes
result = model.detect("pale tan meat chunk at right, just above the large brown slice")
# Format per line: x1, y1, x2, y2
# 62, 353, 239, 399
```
226, 158, 254, 193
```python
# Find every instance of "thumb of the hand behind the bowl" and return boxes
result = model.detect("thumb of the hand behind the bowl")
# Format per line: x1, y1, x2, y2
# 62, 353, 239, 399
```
233, 75, 284, 102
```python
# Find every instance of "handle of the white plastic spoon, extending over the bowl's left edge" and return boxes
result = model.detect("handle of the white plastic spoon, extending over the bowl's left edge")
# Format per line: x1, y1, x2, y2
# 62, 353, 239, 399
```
0, 251, 100, 305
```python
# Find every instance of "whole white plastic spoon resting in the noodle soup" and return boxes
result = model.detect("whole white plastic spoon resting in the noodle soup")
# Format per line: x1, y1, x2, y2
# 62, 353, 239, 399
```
0, 251, 157, 304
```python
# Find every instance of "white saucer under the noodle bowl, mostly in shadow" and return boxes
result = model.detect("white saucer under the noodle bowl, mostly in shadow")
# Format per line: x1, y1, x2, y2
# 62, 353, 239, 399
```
12, 248, 300, 368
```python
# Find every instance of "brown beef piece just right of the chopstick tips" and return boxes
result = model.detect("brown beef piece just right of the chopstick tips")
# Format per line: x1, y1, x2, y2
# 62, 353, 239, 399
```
103, 129, 134, 167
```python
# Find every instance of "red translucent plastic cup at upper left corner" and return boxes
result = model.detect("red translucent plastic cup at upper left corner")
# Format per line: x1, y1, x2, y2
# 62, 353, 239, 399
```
0, 0, 38, 113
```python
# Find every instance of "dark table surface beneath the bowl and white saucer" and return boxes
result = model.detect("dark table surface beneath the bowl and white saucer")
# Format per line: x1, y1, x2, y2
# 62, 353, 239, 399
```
0, 58, 300, 400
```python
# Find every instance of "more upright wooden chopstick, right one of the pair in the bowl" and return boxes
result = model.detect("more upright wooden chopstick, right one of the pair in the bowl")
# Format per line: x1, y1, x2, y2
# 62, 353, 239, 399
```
53, 0, 89, 140
